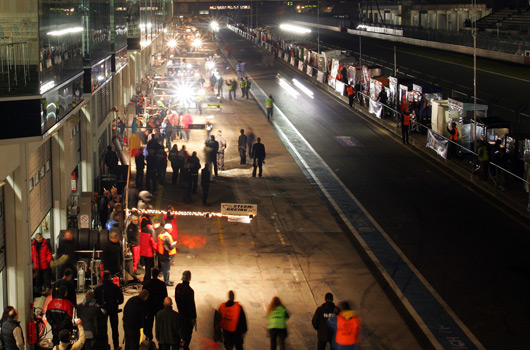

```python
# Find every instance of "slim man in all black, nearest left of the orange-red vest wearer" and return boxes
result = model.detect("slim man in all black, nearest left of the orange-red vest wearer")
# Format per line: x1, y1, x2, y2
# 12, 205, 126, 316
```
175, 271, 197, 350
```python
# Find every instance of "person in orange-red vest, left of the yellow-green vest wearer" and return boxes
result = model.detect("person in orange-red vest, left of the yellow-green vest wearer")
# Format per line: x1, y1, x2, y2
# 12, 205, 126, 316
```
216, 291, 248, 350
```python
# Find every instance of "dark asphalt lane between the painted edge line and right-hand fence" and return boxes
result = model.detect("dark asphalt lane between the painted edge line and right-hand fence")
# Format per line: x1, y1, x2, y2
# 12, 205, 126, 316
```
218, 30, 530, 349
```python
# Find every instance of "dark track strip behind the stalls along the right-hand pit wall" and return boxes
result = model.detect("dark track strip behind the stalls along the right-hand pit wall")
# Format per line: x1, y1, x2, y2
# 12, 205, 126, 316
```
296, 29, 530, 129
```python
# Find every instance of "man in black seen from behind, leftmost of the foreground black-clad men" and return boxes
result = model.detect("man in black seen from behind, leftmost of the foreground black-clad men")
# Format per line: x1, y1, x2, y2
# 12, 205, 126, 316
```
94, 270, 123, 350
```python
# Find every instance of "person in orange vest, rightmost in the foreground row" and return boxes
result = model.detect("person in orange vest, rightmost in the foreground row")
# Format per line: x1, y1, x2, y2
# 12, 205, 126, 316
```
328, 301, 361, 350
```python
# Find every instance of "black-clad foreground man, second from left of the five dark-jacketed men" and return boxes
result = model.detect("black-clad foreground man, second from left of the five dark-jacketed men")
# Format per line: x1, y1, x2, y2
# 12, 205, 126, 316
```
123, 289, 148, 350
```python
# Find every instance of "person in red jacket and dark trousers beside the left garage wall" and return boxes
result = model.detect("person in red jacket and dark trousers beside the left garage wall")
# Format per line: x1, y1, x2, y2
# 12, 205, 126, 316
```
31, 233, 53, 292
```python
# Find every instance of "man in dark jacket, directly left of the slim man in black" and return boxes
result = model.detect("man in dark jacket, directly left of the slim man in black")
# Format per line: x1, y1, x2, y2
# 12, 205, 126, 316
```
156, 298, 181, 350
